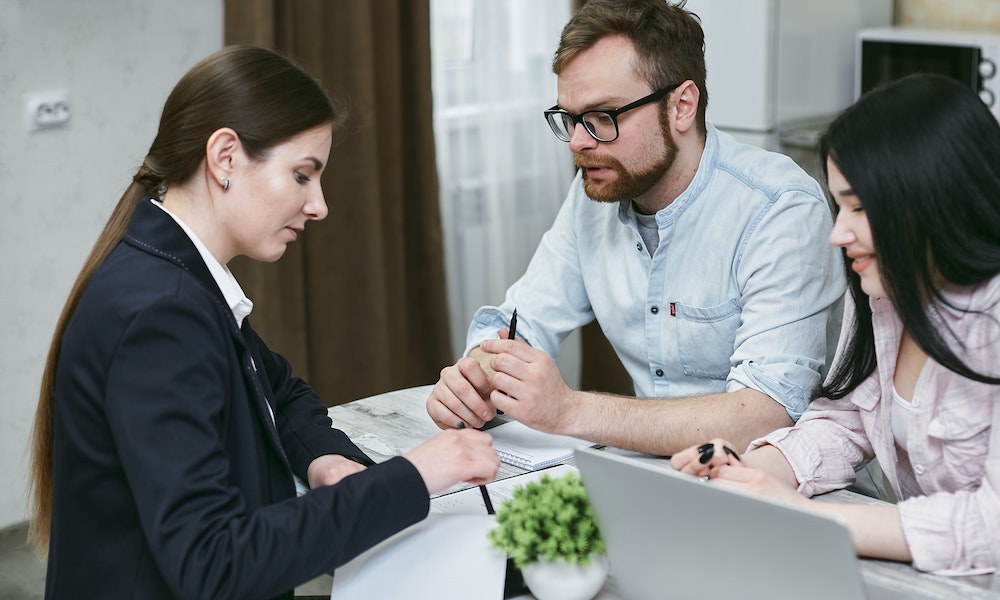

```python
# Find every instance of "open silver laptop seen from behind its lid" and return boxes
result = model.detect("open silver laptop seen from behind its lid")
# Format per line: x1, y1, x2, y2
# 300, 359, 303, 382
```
575, 448, 914, 600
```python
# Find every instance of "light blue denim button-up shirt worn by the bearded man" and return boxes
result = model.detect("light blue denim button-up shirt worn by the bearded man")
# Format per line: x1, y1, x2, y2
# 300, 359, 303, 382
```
466, 125, 845, 420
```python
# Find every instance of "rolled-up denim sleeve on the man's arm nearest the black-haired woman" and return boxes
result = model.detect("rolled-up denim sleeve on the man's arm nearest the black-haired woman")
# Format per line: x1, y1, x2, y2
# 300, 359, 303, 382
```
726, 190, 846, 420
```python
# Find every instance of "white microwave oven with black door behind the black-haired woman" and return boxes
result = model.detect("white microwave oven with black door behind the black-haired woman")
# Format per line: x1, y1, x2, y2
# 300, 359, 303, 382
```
854, 27, 1000, 120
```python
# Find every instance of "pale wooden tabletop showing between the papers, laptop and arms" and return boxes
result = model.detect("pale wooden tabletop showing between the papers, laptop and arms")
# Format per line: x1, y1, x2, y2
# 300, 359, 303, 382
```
328, 385, 1000, 600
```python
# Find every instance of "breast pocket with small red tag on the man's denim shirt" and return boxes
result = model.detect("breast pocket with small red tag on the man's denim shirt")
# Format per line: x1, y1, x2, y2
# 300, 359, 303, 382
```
671, 299, 741, 379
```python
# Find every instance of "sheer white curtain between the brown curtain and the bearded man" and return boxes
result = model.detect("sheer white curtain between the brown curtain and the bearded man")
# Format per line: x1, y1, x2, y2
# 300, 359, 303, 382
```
431, 0, 579, 385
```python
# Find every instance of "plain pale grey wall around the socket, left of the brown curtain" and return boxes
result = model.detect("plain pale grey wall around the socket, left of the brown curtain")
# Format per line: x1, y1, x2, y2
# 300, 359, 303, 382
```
0, 0, 224, 528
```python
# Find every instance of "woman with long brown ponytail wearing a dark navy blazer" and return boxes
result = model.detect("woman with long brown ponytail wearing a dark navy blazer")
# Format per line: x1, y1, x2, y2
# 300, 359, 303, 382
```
31, 46, 499, 599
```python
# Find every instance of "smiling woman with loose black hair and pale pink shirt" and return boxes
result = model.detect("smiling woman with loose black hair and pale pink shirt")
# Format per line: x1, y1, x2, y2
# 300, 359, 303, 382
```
672, 75, 1000, 574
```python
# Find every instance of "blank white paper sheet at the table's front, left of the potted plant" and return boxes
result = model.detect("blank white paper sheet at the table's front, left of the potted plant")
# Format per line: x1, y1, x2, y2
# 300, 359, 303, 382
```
330, 510, 507, 600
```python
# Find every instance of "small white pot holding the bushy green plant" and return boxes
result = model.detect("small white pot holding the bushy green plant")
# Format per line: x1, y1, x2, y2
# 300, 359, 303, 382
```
521, 554, 609, 600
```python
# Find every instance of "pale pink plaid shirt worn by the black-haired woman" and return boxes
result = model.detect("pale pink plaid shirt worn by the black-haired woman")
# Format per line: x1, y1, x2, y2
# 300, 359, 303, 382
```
751, 277, 1000, 575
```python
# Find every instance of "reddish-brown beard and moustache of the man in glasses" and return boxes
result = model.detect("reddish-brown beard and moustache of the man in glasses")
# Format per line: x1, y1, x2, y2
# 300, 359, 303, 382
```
573, 115, 677, 202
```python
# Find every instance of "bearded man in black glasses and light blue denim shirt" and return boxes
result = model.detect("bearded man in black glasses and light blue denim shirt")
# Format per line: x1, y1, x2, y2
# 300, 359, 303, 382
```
427, 0, 845, 455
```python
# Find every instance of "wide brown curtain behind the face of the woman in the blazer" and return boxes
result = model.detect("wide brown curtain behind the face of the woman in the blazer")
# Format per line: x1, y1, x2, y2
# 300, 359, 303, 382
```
225, 0, 453, 405
